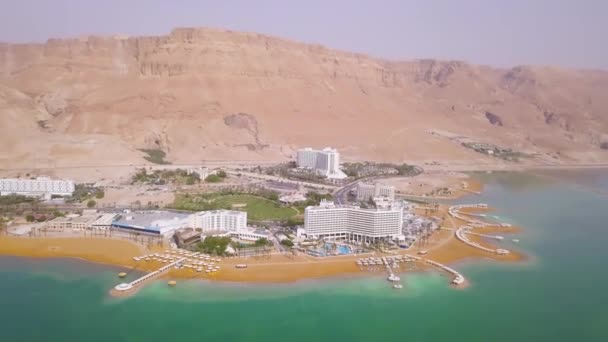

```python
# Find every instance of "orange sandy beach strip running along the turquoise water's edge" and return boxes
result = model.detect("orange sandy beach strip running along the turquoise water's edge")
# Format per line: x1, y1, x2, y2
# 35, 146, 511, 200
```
0, 179, 527, 284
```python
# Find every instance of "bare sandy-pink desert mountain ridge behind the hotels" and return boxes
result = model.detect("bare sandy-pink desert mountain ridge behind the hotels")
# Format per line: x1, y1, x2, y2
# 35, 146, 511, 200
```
0, 28, 608, 168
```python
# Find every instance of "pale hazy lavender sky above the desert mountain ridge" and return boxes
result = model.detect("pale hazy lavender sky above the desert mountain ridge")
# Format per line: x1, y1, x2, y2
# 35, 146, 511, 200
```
0, 0, 608, 69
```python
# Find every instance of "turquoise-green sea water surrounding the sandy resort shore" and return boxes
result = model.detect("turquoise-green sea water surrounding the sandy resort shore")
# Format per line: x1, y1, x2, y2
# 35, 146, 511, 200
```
0, 171, 608, 342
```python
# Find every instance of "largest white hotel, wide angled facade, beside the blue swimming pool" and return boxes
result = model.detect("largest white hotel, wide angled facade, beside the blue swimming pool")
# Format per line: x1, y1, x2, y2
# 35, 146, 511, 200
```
304, 201, 403, 242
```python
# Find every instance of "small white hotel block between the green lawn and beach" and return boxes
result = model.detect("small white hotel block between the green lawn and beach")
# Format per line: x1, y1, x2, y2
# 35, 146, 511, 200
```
189, 210, 247, 233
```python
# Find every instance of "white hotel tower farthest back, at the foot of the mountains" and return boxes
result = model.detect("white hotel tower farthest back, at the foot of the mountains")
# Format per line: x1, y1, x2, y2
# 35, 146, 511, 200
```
296, 147, 346, 179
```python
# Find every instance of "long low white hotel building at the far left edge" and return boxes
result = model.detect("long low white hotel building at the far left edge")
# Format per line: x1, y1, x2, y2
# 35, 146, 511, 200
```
0, 177, 75, 199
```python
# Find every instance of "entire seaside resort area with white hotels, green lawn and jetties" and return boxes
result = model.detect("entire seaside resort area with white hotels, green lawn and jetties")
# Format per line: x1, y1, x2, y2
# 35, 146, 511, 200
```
0, 156, 517, 295
